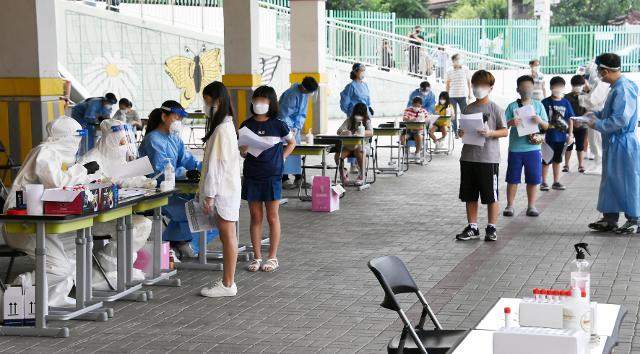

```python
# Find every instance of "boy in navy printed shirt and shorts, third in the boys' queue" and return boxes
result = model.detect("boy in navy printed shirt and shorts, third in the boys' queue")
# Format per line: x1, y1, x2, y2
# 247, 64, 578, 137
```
540, 76, 575, 191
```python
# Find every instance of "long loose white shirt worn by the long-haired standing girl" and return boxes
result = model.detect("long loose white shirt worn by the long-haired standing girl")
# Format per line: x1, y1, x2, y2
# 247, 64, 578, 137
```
200, 117, 242, 221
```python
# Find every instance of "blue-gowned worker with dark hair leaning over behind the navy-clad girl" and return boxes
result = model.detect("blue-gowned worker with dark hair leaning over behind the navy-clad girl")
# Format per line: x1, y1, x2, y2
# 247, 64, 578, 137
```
278, 76, 318, 189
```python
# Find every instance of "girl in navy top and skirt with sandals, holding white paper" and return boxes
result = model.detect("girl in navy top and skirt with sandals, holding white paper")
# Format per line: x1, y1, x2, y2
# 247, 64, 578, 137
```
240, 86, 296, 272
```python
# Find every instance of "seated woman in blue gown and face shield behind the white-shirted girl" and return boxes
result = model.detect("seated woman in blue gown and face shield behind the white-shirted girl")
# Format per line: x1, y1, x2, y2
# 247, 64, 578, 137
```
140, 101, 217, 258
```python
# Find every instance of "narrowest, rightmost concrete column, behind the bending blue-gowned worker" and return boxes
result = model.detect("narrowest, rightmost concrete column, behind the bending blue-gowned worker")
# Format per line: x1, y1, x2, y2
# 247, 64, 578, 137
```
289, 0, 329, 134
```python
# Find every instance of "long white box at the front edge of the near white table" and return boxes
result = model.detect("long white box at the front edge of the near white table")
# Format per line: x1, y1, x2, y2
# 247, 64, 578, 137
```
493, 327, 589, 354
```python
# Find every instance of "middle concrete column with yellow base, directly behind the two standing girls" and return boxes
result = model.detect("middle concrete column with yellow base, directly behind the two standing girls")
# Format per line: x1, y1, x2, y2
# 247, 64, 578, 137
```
222, 0, 261, 125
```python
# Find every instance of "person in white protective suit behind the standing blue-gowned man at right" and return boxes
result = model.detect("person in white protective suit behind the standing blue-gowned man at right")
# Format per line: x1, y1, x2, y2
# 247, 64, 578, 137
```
578, 58, 610, 174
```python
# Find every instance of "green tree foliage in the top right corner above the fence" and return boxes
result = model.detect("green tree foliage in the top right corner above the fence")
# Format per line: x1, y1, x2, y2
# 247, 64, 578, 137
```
551, 0, 640, 26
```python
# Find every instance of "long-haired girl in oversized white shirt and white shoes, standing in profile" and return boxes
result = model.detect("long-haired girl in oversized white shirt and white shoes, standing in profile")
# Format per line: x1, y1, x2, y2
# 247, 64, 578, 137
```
198, 81, 241, 297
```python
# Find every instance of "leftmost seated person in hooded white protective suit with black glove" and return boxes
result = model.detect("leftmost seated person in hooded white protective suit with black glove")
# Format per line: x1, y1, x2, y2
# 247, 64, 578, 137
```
4, 116, 99, 307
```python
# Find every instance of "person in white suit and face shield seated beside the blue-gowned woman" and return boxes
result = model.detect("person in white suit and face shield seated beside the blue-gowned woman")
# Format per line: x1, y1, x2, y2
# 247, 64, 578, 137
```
81, 119, 152, 290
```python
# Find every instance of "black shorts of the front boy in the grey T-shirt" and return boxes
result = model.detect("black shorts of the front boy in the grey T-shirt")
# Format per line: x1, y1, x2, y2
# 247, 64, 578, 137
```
459, 161, 499, 204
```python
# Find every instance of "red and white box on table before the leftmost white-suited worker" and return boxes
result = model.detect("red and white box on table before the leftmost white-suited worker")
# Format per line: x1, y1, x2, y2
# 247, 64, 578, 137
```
42, 185, 100, 215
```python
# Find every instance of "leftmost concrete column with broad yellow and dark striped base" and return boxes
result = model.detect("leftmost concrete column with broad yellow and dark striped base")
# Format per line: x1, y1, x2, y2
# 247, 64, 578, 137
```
0, 0, 64, 177
